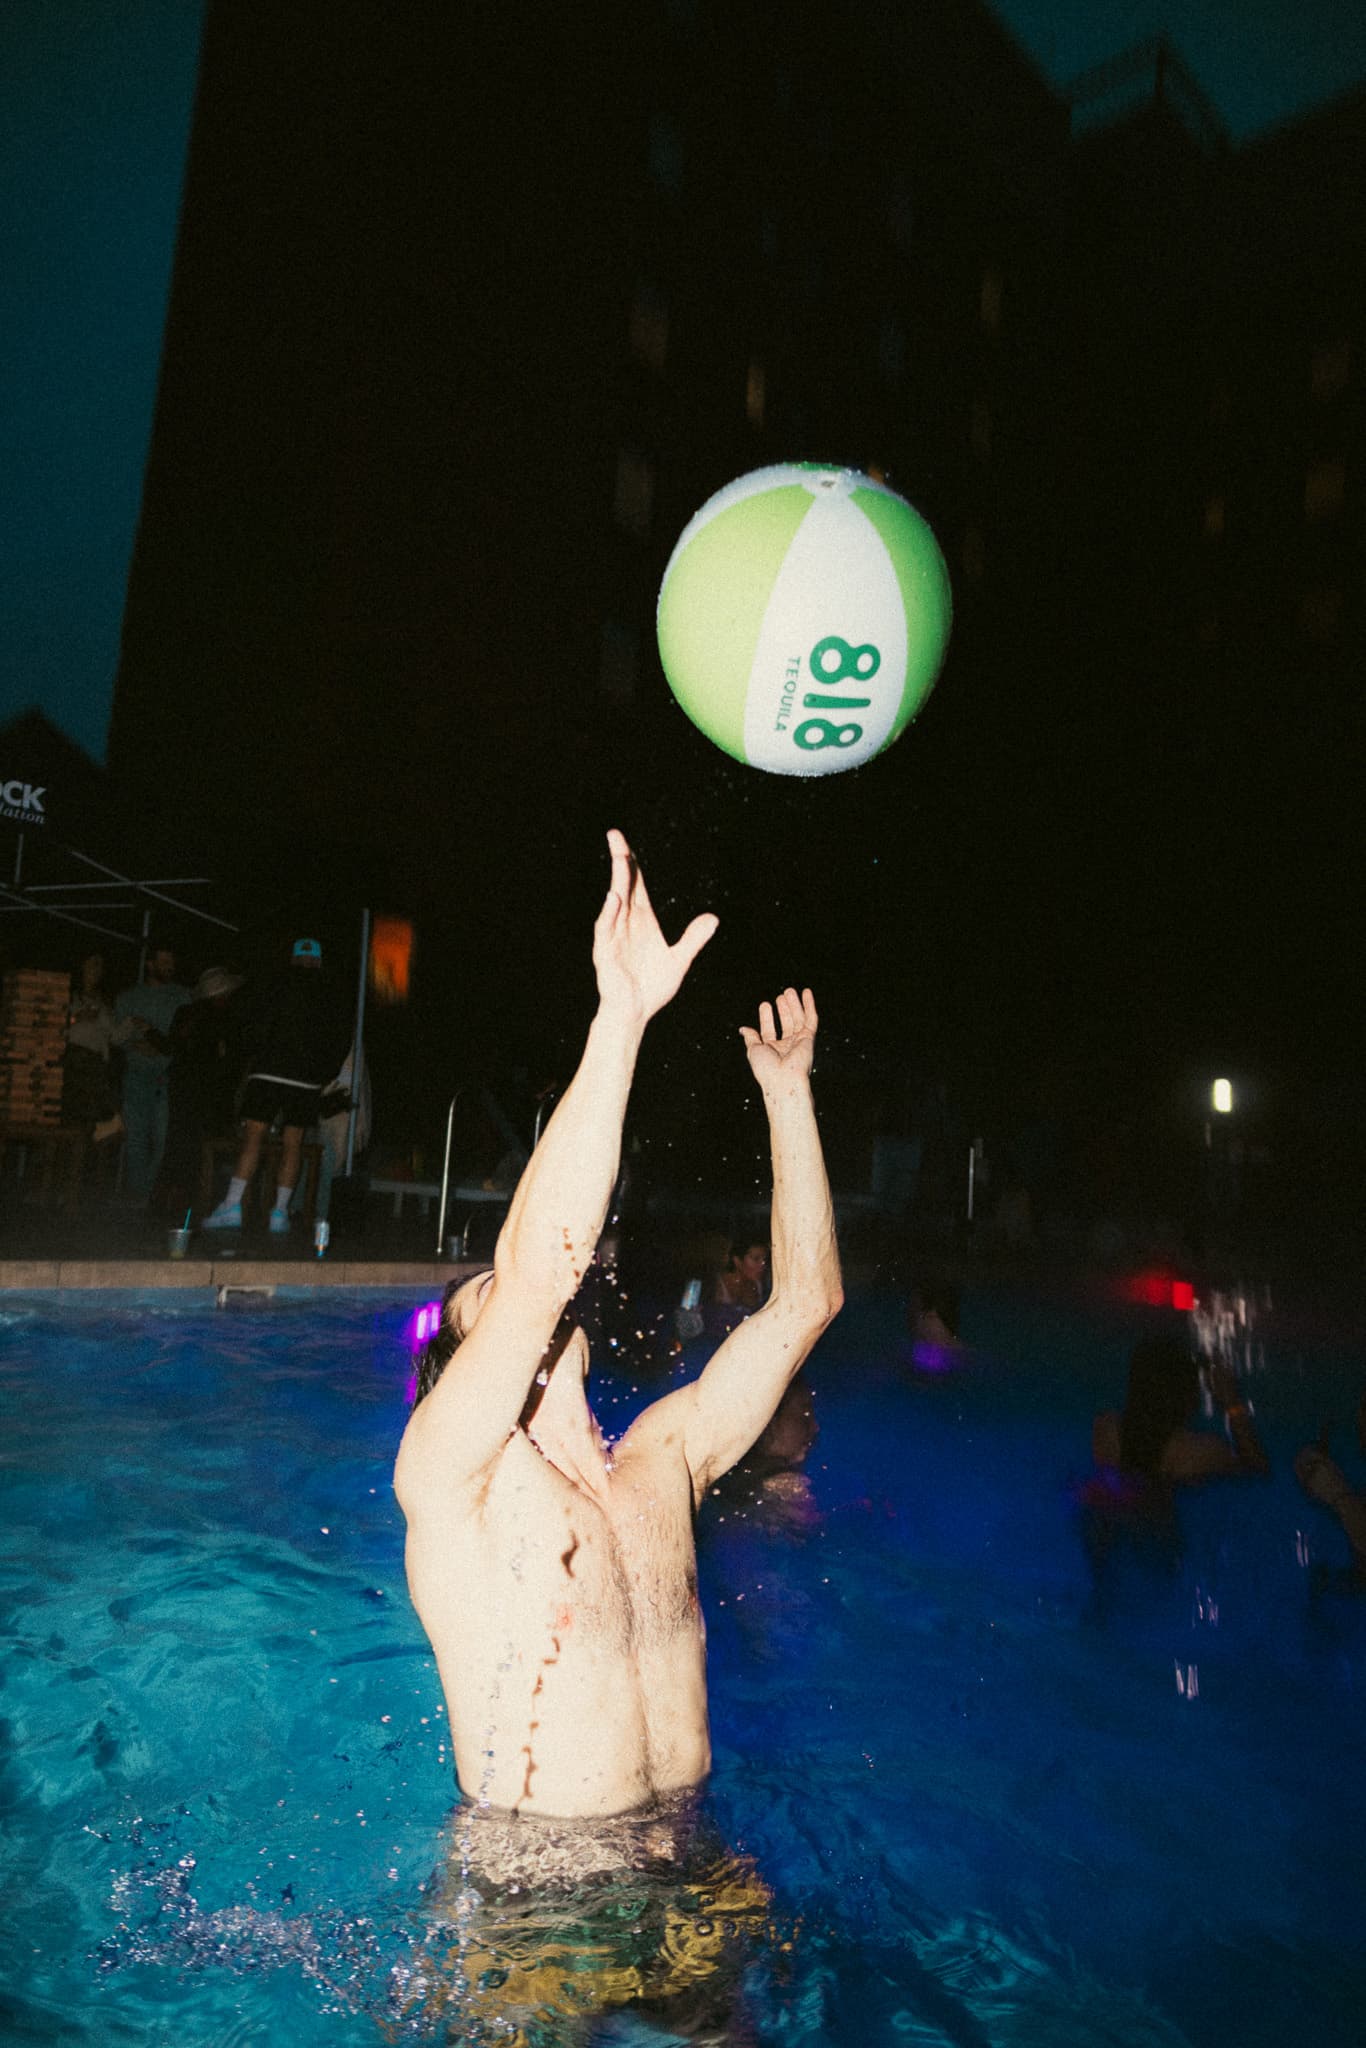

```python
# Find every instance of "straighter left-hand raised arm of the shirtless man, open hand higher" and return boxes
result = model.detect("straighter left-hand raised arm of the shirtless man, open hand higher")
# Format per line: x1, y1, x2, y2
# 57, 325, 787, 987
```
397, 831, 717, 1491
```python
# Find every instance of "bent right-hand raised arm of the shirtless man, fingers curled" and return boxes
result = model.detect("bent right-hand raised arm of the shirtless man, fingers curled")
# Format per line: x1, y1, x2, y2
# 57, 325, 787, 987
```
657, 989, 844, 1501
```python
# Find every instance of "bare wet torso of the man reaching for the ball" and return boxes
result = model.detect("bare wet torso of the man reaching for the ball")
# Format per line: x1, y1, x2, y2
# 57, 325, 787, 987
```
408, 1411, 711, 1817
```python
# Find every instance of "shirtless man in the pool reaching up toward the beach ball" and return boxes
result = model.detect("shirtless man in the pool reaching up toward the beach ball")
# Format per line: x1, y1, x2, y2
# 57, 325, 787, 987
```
395, 831, 842, 1821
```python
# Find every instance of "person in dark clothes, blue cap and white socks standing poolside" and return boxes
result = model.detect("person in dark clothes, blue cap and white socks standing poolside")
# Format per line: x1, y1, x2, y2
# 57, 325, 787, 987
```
203, 938, 350, 1237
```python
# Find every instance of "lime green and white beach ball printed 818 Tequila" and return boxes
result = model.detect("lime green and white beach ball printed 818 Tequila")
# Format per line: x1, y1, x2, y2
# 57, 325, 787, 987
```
657, 463, 952, 776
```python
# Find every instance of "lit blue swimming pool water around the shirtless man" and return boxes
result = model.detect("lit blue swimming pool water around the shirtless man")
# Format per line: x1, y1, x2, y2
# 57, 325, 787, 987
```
0, 1290, 1366, 2048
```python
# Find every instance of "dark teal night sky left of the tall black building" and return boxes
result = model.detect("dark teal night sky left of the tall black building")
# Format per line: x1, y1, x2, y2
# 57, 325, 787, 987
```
0, 0, 203, 758
